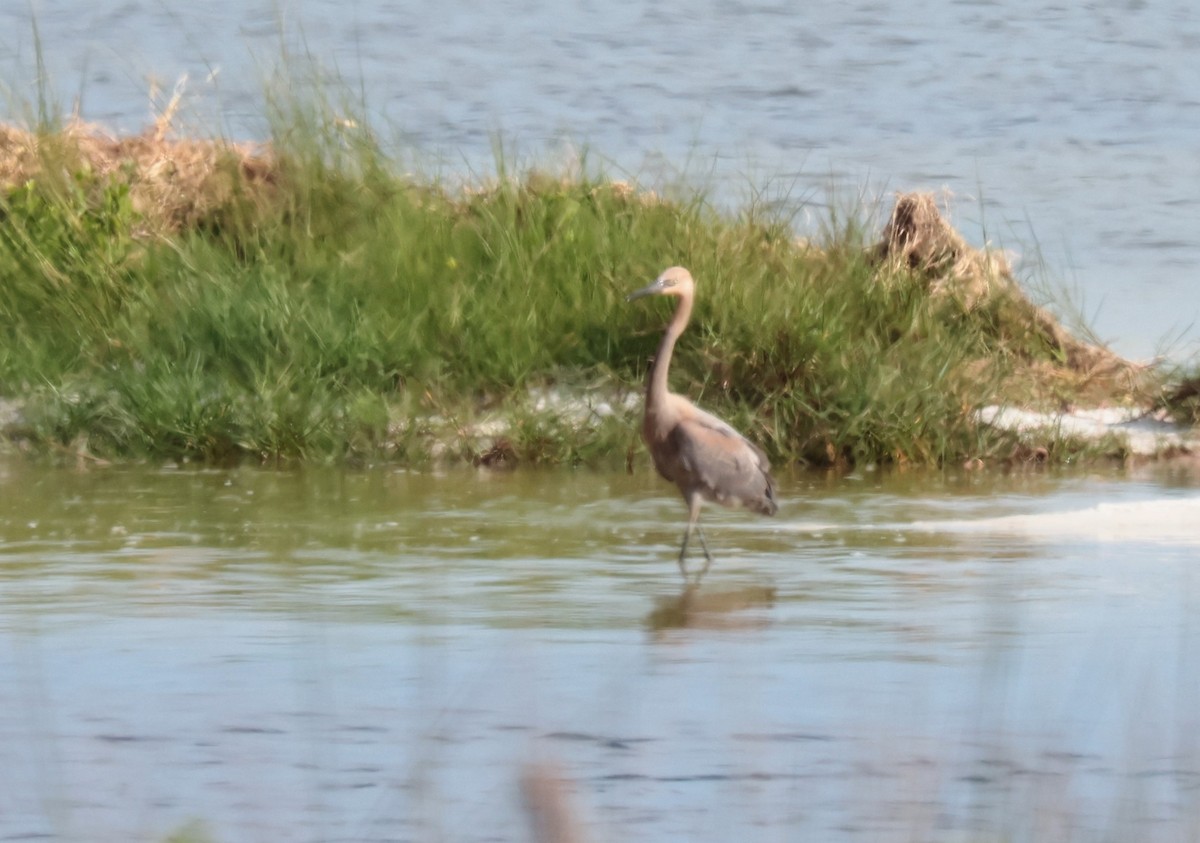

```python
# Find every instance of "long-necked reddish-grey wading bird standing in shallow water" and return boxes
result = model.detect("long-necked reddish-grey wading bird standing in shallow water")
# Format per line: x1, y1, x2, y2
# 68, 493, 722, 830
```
625, 267, 778, 580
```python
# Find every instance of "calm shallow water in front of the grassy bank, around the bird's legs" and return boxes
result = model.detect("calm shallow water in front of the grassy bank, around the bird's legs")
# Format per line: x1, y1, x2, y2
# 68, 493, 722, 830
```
0, 461, 1200, 843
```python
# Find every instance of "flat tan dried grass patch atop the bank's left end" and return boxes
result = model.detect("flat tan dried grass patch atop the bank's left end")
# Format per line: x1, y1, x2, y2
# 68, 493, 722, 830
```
0, 112, 278, 234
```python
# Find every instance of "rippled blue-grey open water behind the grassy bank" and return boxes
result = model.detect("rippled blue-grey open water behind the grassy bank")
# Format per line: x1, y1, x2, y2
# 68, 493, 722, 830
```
0, 0, 1200, 359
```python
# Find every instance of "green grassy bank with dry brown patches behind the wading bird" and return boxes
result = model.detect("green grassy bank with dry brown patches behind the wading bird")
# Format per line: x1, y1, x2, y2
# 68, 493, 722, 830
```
0, 84, 1195, 465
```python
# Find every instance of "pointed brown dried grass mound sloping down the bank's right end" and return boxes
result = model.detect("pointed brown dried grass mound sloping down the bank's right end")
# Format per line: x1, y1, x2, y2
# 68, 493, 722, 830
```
874, 193, 1146, 401
